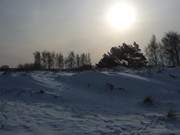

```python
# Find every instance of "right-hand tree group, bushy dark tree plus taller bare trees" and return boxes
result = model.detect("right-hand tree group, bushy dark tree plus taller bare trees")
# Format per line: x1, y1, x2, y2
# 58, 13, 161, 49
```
97, 31, 180, 68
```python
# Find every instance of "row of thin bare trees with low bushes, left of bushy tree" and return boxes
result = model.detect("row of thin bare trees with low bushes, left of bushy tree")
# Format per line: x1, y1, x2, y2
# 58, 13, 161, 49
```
17, 51, 92, 70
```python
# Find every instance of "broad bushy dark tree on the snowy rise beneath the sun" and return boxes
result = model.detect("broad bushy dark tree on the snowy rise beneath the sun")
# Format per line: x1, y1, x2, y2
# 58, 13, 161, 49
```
97, 42, 147, 68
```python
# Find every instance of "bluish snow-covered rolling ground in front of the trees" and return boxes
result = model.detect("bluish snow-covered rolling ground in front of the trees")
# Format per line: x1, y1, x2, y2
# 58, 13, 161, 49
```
0, 68, 180, 135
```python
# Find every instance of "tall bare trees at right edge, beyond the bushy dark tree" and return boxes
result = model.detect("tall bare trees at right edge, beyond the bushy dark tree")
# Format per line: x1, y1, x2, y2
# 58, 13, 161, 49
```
145, 31, 180, 67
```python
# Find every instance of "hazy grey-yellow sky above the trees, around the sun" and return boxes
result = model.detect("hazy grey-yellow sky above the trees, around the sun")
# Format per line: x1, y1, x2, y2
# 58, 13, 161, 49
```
0, 0, 180, 65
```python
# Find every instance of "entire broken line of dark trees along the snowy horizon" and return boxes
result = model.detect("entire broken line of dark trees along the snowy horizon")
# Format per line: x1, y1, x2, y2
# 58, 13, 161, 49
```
0, 31, 180, 70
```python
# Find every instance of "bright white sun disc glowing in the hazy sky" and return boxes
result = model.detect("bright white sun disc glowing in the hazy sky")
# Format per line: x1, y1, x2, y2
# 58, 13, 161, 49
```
107, 4, 136, 30
